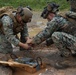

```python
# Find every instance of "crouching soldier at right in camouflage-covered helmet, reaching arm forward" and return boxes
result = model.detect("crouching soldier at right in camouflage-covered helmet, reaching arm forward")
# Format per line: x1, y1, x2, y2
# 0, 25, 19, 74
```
28, 0, 76, 68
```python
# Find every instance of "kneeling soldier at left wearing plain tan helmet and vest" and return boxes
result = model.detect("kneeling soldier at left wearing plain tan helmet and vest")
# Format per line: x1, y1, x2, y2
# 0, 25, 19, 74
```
0, 7, 33, 75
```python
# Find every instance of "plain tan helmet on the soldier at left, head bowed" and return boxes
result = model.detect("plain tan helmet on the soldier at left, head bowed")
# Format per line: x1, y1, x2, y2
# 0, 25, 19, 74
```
17, 7, 33, 23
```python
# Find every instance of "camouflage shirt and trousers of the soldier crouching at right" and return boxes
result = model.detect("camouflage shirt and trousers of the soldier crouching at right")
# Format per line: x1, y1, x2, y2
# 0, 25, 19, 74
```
33, 15, 76, 54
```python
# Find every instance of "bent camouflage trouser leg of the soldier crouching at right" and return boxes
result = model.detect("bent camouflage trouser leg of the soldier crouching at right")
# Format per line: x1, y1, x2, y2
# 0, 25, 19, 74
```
52, 32, 76, 56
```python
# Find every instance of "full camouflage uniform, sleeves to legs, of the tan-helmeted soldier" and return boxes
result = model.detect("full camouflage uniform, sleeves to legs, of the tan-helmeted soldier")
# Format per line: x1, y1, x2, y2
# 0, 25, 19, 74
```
0, 13, 28, 75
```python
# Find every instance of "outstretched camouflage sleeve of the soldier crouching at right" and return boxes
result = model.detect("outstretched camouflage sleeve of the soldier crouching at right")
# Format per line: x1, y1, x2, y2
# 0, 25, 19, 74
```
33, 17, 67, 44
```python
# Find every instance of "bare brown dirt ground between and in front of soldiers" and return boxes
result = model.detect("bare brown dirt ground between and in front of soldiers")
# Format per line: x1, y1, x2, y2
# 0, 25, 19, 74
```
11, 12, 76, 75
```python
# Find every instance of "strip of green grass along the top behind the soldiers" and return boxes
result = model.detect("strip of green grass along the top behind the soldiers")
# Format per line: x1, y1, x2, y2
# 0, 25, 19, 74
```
0, 0, 69, 10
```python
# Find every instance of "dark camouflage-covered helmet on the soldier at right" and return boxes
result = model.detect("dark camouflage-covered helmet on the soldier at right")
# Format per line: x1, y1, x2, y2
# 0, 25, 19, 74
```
41, 2, 59, 19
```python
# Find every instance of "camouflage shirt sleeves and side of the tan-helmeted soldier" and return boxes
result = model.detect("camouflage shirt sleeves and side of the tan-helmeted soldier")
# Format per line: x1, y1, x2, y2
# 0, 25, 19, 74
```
0, 16, 28, 53
